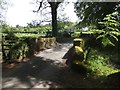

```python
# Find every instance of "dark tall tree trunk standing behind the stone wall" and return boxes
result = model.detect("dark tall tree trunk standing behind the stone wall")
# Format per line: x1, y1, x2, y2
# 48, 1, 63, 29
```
34, 0, 63, 37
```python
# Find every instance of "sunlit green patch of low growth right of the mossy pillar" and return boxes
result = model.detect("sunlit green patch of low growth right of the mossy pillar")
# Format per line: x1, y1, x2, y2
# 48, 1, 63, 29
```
88, 49, 120, 76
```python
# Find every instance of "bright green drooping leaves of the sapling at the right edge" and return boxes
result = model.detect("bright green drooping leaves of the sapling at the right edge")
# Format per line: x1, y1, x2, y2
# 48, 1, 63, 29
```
97, 12, 120, 46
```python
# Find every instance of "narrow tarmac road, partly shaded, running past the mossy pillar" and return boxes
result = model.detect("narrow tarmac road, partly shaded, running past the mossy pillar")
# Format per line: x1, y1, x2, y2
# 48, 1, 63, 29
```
2, 43, 96, 90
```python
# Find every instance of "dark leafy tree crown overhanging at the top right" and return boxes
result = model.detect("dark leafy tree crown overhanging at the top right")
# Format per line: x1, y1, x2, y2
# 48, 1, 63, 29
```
75, 0, 120, 27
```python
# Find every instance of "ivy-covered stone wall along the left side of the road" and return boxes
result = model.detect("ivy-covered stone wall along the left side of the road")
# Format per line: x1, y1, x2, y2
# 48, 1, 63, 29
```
2, 36, 55, 63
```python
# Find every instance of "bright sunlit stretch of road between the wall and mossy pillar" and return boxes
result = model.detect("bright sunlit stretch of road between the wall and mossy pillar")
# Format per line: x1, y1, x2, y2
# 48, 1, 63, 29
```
36, 43, 72, 62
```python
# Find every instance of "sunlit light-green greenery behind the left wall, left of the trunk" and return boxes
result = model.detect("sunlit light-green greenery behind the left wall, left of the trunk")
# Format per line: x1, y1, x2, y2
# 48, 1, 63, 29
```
1, 25, 51, 37
